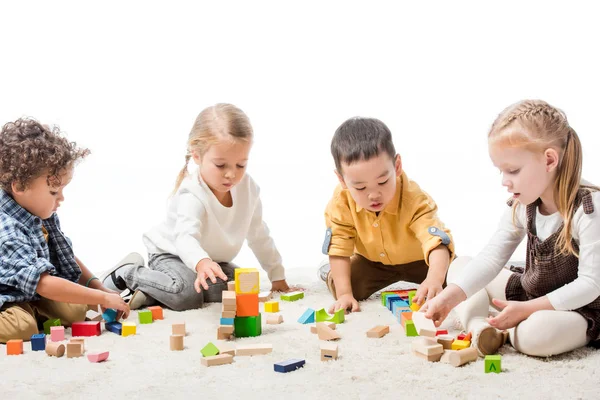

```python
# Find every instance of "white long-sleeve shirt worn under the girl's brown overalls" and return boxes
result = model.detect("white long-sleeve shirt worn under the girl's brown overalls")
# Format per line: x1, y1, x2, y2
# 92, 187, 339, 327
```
452, 192, 600, 311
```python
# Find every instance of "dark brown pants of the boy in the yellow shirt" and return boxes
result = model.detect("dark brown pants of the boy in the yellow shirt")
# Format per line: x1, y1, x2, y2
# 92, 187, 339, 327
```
327, 254, 429, 301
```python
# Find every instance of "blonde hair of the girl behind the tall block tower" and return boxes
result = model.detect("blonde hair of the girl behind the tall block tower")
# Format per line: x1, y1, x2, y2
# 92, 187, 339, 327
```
173, 103, 253, 193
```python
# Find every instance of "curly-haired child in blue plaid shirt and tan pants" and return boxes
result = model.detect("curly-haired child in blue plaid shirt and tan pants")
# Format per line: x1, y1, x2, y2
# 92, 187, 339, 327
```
0, 119, 129, 343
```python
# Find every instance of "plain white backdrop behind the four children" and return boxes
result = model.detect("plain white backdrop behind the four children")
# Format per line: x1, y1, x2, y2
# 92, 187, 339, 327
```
0, 1, 600, 272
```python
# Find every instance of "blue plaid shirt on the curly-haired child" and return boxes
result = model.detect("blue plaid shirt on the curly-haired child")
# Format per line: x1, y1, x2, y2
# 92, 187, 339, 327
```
0, 189, 81, 307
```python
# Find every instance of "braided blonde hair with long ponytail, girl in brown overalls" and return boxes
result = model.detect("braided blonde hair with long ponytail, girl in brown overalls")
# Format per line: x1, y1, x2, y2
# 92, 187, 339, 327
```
488, 100, 597, 256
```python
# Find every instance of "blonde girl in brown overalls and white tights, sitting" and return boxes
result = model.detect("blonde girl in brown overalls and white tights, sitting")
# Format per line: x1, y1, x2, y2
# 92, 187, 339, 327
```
423, 100, 600, 356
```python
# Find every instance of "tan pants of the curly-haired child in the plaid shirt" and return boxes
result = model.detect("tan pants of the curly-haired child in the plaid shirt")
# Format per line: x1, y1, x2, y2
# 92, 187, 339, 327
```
0, 298, 88, 343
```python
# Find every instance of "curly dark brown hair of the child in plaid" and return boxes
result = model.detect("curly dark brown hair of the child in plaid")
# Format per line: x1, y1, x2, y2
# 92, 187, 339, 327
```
0, 118, 90, 192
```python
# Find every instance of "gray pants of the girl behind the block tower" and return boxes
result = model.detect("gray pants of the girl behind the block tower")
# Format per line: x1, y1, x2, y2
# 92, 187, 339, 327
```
123, 253, 237, 311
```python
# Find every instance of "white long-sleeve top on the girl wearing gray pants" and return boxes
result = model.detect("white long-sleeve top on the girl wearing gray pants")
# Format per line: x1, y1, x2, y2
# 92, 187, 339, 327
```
143, 170, 285, 281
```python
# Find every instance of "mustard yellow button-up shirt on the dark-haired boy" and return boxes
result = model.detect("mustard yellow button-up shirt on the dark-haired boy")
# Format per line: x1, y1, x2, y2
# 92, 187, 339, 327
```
325, 172, 454, 265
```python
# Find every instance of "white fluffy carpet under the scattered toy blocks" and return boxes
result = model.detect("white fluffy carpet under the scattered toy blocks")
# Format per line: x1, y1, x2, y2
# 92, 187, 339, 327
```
0, 269, 600, 400
